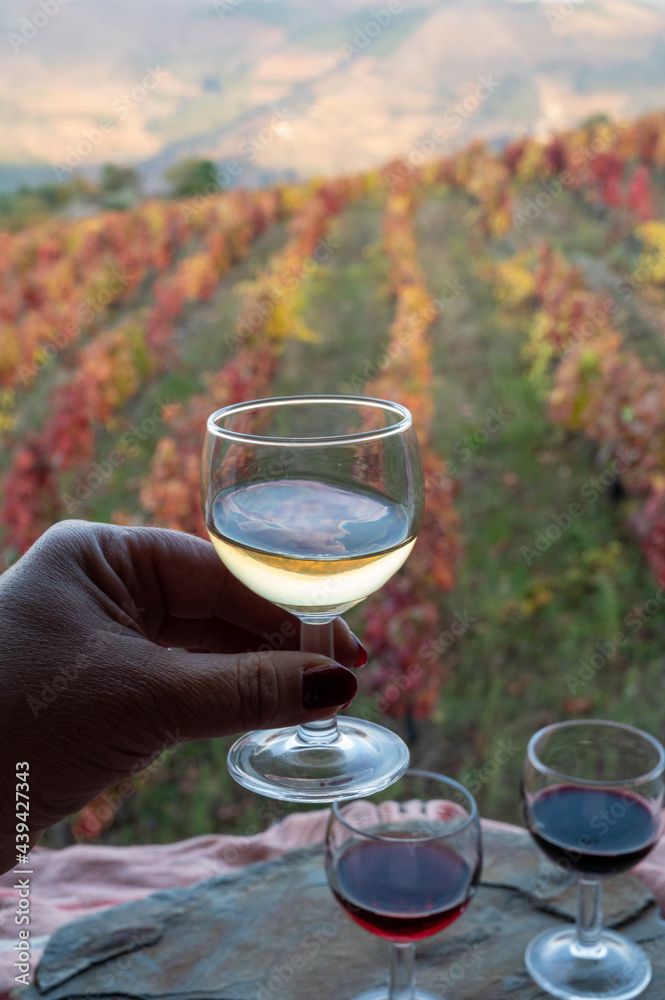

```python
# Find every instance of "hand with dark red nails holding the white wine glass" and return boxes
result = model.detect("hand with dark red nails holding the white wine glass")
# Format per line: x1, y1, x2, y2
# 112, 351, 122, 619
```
0, 521, 365, 871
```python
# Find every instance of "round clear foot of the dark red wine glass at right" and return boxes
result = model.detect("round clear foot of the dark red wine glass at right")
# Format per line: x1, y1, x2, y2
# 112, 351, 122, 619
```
524, 927, 651, 1000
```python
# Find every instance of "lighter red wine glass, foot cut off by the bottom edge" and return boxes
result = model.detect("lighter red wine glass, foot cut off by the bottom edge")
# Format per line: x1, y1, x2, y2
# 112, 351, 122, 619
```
325, 770, 482, 1000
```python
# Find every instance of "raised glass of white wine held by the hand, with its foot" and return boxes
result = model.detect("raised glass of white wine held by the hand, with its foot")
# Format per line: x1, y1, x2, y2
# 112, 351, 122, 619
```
202, 396, 424, 802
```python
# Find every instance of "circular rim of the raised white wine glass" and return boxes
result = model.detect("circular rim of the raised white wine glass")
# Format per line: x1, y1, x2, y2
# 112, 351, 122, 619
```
206, 394, 413, 447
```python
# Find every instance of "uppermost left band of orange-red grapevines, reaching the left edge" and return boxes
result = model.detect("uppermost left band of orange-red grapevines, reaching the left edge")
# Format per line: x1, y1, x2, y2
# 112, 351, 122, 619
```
0, 192, 276, 420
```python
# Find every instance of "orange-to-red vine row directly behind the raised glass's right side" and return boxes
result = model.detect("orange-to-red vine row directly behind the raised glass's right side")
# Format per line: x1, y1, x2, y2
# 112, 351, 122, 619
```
362, 184, 461, 720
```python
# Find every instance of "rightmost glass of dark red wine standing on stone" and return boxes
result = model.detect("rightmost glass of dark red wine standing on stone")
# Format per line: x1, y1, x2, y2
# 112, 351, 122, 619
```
521, 719, 665, 1000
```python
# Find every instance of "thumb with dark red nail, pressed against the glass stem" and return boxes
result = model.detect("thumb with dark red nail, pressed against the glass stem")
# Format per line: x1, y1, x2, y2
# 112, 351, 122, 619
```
151, 650, 358, 740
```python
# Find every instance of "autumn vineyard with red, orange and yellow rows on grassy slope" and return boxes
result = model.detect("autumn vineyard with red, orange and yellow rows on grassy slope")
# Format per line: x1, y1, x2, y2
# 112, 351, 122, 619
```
0, 114, 665, 842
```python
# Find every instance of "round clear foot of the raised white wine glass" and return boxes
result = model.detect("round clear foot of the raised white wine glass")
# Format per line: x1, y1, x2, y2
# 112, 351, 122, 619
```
228, 715, 409, 803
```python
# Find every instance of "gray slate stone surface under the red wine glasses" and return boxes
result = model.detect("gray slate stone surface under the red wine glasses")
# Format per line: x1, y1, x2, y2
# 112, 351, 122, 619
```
23, 831, 665, 1000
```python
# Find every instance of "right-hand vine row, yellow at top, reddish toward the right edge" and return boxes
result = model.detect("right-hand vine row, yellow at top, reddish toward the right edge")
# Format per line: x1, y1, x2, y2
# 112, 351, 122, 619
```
486, 247, 665, 584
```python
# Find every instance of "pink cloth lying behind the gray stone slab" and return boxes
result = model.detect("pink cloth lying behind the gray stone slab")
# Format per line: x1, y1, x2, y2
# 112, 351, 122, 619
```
0, 809, 665, 1000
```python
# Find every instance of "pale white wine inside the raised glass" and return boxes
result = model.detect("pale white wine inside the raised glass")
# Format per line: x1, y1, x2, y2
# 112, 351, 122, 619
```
210, 479, 415, 617
